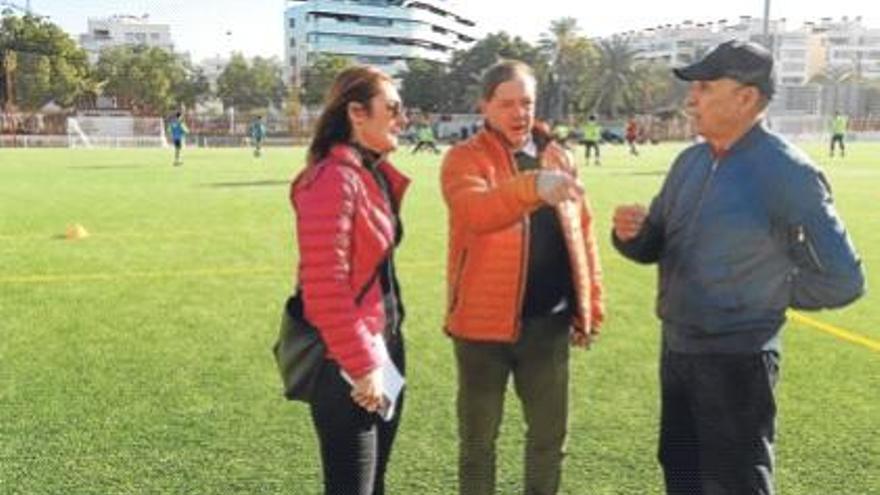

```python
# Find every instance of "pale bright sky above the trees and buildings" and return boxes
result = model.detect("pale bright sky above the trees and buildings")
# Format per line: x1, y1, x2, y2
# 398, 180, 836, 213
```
17, 0, 880, 61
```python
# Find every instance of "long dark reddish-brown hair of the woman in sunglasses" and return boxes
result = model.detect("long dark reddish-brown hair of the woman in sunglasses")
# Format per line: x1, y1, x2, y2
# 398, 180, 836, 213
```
308, 65, 391, 165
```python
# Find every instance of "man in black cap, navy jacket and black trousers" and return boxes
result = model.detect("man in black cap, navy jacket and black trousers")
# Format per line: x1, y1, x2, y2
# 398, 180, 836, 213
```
613, 41, 865, 495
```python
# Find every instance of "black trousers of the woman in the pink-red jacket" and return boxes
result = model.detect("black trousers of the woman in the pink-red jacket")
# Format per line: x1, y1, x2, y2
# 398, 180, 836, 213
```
311, 334, 404, 495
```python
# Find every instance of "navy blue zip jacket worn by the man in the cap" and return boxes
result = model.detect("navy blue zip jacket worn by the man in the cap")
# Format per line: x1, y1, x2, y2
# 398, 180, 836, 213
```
613, 124, 865, 353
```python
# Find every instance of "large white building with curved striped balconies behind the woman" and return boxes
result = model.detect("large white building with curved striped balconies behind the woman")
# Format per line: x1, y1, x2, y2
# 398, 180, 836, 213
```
284, 0, 480, 80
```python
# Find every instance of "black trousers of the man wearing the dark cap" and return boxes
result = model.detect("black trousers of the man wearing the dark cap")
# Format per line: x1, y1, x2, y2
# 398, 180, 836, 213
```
658, 351, 779, 495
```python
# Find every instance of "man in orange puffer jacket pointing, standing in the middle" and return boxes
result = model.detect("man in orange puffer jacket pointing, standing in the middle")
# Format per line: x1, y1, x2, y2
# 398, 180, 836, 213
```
441, 61, 604, 495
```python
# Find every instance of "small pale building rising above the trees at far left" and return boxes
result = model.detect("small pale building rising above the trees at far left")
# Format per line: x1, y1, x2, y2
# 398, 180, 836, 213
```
79, 14, 174, 62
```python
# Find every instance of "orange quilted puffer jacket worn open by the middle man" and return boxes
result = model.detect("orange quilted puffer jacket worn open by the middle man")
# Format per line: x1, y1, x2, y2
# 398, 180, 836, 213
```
441, 130, 605, 342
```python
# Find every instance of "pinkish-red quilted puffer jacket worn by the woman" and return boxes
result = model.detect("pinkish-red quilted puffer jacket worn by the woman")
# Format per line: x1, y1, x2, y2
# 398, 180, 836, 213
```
290, 145, 409, 377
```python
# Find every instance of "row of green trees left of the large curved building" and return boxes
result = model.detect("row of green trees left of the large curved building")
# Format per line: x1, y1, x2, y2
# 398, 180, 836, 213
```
0, 10, 288, 115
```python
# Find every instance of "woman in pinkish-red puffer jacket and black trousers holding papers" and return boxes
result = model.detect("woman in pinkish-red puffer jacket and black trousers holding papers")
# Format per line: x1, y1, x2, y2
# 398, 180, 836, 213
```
291, 67, 409, 495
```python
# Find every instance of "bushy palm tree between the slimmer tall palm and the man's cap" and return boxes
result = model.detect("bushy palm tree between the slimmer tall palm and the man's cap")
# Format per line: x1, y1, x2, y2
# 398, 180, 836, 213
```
591, 36, 639, 118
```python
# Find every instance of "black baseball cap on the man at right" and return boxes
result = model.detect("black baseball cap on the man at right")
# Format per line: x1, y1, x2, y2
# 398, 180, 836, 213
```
672, 40, 776, 98
